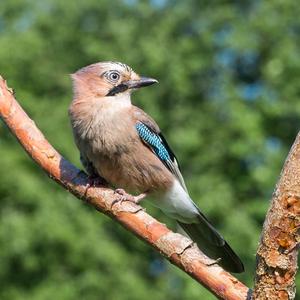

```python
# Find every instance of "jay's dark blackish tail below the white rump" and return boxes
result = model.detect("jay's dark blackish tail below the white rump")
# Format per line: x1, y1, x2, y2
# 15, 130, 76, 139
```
177, 211, 244, 273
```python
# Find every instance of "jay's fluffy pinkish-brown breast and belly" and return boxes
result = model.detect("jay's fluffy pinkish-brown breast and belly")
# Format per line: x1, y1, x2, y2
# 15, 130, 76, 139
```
71, 102, 174, 192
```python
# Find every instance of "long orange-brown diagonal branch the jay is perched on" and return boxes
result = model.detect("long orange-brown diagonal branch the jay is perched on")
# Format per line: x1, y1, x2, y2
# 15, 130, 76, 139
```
0, 76, 250, 300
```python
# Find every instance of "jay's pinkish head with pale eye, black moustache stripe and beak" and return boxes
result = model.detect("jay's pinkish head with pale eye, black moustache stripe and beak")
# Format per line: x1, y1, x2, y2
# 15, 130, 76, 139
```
72, 62, 157, 98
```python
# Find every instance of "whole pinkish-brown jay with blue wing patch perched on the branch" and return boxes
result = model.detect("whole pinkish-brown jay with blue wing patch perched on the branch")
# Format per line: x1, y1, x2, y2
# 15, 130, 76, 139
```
68, 61, 244, 273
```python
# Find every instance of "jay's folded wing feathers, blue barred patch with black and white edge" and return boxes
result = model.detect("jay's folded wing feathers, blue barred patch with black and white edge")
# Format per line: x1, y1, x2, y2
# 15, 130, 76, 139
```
135, 122, 187, 190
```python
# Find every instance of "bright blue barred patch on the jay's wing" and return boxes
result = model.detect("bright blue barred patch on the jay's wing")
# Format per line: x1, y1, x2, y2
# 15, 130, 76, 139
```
135, 122, 171, 161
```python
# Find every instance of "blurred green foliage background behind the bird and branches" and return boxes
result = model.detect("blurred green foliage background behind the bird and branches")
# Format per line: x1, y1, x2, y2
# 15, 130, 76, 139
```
0, 0, 300, 300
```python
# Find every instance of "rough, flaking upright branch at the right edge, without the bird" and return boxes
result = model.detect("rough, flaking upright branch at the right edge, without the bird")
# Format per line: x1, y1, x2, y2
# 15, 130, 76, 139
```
253, 133, 300, 300
